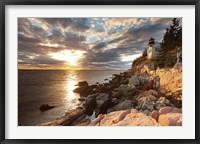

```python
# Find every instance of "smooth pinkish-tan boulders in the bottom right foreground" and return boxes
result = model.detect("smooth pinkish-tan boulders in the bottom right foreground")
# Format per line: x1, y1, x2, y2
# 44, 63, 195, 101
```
90, 107, 182, 126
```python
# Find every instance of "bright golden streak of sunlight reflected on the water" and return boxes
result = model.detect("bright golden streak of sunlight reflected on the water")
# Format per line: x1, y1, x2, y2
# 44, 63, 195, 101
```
64, 71, 79, 110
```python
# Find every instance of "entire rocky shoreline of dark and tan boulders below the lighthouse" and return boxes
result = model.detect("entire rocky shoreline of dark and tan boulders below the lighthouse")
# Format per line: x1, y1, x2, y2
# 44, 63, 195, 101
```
38, 65, 182, 126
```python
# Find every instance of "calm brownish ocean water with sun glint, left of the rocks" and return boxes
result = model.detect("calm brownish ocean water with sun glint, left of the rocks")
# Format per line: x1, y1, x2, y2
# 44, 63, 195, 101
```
18, 70, 123, 126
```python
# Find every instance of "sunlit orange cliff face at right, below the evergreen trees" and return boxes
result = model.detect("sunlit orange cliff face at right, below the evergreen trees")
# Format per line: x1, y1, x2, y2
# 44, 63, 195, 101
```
141, 65, 182, 107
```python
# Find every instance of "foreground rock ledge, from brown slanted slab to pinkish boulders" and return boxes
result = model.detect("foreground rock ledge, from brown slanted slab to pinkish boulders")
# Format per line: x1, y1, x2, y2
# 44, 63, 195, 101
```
37, 107, 182, 126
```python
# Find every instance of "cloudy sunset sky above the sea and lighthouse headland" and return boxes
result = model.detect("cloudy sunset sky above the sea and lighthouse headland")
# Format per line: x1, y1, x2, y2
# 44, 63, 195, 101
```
18, 18, 175, 70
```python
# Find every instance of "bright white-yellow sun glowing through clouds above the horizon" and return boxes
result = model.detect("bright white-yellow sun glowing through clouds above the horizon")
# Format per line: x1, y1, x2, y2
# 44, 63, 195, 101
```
48, 50, 85, 66
